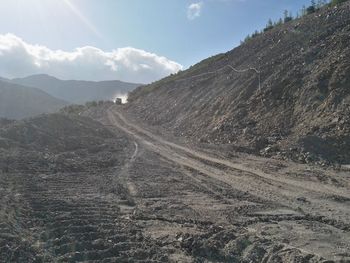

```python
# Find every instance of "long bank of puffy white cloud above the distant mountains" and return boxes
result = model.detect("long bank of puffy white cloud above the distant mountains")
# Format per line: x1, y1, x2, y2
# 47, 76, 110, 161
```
0, 34, 182, 83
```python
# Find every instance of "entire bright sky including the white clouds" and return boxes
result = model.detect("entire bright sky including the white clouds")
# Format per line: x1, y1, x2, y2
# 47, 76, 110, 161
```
0, 0, 316, 83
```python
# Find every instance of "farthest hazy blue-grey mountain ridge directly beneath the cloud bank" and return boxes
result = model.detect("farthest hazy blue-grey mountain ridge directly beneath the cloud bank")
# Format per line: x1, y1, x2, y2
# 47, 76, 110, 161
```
12, 75, 139, 104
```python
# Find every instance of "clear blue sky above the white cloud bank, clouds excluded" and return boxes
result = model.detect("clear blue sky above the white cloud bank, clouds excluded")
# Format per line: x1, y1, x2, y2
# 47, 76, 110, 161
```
0, 0, 318, 82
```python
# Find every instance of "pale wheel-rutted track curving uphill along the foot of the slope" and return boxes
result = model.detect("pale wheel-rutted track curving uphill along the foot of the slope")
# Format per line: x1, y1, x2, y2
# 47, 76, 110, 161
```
108, 109, 350, 228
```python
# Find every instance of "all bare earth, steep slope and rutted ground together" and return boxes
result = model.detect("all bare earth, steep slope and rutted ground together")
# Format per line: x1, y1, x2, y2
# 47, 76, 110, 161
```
0, 4, 350, 263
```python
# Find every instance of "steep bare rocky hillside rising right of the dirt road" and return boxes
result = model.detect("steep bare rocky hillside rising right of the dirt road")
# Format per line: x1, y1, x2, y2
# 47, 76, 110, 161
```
128, 2, 350, 164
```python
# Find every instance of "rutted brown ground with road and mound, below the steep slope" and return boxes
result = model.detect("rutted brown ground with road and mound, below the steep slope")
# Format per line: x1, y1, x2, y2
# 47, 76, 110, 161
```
0, 103, 350, 263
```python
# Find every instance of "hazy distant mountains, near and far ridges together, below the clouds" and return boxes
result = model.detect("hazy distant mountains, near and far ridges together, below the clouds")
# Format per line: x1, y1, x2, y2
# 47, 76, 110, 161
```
0, 75, 140, 119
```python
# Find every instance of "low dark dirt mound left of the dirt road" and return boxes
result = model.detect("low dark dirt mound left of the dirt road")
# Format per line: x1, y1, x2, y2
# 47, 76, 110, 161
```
0, 113, 131, 173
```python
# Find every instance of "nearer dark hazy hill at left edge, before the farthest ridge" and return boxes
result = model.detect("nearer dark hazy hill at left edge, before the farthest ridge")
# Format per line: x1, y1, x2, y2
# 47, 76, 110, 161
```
0, 80, 68, 119
